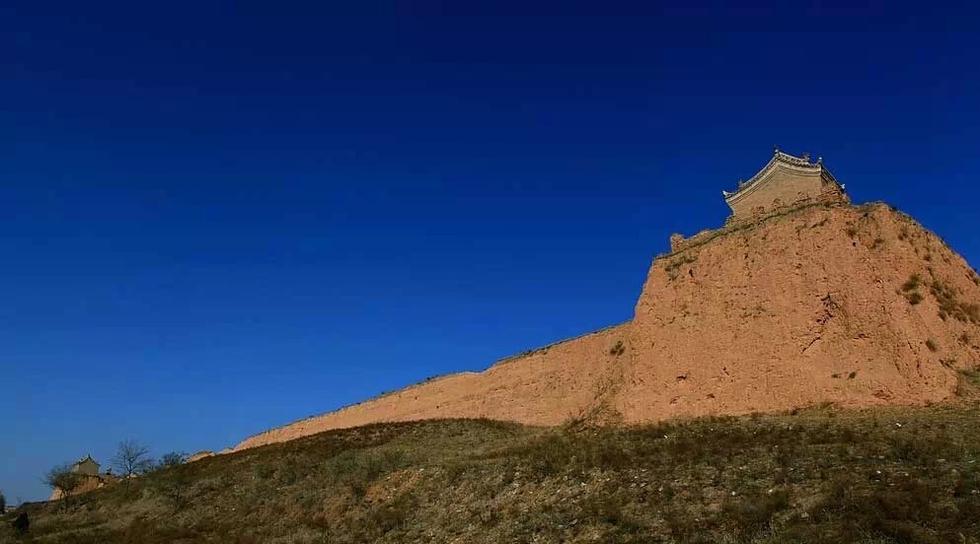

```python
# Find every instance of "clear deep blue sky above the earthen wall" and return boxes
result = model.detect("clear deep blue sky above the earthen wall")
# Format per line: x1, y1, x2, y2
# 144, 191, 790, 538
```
0, 2, 980, 500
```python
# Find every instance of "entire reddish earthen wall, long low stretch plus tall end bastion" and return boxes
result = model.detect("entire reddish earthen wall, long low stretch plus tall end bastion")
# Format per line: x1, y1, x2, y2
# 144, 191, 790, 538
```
234, 204, 980, 450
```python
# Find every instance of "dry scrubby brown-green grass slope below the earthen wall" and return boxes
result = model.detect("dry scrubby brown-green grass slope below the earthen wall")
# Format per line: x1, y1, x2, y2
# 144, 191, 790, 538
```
0, 406, 980, 544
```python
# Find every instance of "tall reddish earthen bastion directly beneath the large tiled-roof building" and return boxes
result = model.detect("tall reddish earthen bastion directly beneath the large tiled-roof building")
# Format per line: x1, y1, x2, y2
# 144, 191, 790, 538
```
618, 205, 980, 422
